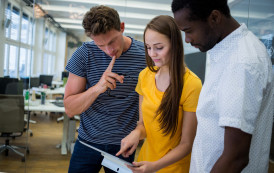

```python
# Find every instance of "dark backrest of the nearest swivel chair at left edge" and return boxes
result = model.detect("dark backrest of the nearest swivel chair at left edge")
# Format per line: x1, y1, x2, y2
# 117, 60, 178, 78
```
0, 94, 25, 133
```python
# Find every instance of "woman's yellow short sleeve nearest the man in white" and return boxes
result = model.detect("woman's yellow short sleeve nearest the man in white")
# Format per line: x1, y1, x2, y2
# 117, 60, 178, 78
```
181, 76, 202, 112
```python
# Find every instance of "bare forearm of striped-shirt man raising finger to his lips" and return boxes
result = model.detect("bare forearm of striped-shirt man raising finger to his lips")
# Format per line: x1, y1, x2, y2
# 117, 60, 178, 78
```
64, 86, 100, 117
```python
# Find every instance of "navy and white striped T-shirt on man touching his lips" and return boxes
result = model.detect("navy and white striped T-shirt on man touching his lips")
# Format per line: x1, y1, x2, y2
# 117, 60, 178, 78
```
66, 38, 146, 145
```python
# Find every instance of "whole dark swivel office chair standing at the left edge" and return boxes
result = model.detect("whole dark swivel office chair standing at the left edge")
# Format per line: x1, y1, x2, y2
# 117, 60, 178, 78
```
0, 95, 29, 162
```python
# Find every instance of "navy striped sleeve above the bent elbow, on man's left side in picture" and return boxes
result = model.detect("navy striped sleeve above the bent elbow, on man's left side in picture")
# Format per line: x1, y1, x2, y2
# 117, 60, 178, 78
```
66, 44, 88, 77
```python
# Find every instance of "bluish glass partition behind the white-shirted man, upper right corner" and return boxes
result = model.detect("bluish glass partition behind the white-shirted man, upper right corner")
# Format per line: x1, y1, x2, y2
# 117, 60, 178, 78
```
231, 0, 274, 63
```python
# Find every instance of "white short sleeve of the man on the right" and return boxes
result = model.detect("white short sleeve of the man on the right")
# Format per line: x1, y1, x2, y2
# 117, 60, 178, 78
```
217, 64, 264, 134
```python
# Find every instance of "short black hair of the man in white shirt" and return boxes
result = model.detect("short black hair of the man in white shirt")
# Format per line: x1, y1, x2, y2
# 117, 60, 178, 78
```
171, 0, 231, 21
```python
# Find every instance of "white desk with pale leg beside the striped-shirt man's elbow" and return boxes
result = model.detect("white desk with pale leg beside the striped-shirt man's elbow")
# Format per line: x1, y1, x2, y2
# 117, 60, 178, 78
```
25, 100, 70, 155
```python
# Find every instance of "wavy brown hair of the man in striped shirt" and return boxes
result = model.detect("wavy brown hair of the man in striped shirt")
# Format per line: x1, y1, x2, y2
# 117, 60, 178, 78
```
82, 5, 121, 37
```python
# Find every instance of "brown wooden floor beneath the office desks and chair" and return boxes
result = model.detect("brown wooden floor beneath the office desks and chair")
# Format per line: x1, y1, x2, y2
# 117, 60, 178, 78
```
0, 114, 274, 173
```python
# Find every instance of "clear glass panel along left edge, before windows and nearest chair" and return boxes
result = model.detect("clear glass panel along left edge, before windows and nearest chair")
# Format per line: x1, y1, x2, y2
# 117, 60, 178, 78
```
0, 0, 34, 172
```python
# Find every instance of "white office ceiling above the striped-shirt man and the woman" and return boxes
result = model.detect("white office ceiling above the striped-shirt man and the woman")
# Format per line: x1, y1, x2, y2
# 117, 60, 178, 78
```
38, 0, 172, 41
